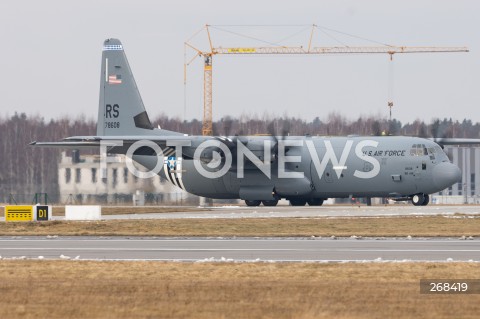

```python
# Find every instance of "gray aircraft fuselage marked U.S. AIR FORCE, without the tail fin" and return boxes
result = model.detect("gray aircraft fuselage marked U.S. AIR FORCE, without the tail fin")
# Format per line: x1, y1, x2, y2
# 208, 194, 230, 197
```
133, 136, 460, 200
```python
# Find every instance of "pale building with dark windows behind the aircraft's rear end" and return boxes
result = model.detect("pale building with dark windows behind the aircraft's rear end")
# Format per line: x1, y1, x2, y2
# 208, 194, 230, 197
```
58, 151, 191, 205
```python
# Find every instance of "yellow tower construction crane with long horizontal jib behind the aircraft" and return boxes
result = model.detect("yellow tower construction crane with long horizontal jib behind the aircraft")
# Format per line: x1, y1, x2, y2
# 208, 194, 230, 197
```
184, 24, 468, 135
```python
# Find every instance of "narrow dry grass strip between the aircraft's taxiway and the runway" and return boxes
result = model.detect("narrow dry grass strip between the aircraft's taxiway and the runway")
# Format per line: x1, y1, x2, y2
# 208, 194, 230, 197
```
0, 215, 480, 237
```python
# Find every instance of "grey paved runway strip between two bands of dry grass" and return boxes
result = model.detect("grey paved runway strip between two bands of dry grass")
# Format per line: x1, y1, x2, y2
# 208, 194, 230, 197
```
0, 237, 480, 262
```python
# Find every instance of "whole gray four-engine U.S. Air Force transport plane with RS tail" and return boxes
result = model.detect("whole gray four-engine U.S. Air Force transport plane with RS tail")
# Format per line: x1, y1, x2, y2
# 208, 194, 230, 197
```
32, 39, 461, 206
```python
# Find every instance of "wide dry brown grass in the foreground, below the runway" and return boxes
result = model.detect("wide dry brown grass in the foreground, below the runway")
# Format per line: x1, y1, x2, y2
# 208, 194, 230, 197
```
0, 260, 480, 319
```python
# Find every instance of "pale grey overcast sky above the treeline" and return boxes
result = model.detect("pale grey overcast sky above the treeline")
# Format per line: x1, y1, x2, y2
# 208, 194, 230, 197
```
0, 0, 480, 123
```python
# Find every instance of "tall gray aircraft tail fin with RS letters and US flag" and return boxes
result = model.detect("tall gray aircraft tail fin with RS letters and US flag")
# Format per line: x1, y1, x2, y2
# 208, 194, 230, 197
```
97, 39, 153, 136
